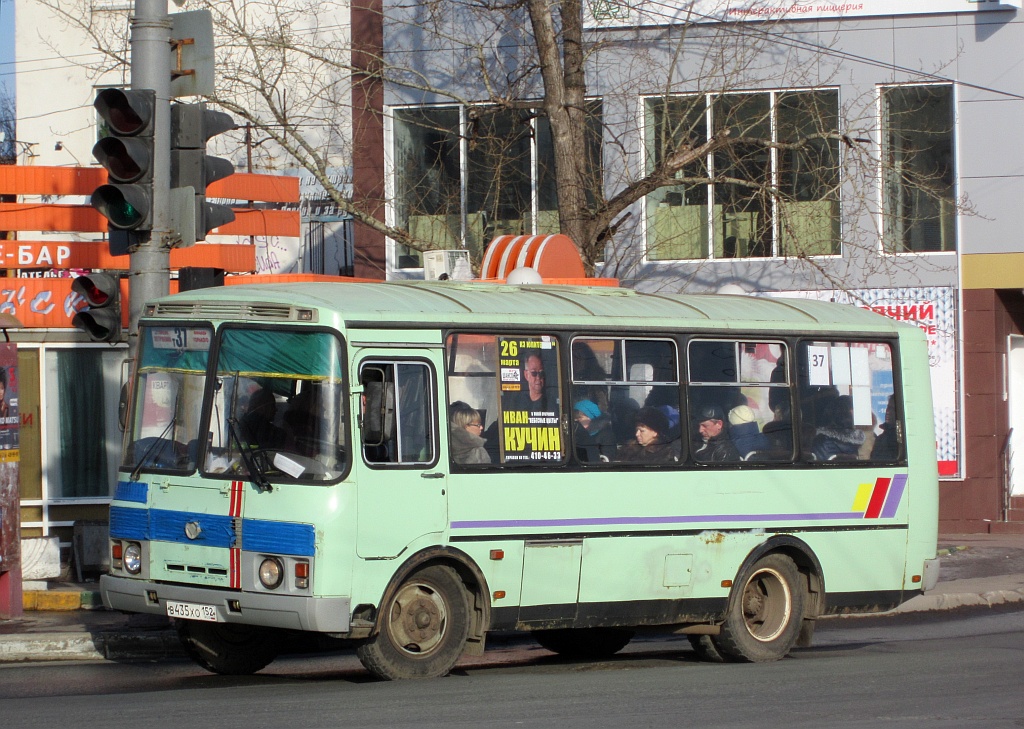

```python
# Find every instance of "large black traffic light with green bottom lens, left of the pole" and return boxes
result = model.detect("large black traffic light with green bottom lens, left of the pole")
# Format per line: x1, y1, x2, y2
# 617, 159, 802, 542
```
91, 88, 157, 239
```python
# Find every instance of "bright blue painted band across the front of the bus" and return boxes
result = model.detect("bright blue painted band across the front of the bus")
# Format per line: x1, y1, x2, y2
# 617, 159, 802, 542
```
111, 506, 316, 557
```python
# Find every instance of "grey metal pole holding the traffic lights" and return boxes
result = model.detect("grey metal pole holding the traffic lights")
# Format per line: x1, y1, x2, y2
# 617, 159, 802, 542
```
128, 0, 172, 356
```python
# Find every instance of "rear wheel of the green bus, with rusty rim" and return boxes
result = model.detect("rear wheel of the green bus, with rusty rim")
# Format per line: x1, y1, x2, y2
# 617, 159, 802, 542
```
714, 554, 807, 663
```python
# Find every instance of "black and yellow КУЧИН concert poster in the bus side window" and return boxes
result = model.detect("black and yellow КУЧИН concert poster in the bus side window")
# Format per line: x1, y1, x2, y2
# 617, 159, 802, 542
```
498, 337, 562, 463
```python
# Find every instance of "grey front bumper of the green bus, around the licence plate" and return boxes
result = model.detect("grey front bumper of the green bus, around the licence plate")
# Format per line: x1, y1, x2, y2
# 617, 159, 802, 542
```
99, 574, 350, 633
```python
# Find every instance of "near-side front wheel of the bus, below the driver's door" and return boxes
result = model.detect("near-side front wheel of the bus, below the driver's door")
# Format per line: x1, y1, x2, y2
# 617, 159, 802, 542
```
355, 565, 469, 681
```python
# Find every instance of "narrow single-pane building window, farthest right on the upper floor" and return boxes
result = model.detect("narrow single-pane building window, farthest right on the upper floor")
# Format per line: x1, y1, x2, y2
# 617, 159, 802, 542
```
882, 85, 956, 253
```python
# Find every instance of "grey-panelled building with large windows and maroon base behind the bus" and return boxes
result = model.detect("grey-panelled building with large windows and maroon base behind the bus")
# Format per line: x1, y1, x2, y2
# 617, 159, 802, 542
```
353, 0, 1024, 532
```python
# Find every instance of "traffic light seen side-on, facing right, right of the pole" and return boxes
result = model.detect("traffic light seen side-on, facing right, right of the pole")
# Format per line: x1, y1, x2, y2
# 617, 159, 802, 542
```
171, 102, 234, 246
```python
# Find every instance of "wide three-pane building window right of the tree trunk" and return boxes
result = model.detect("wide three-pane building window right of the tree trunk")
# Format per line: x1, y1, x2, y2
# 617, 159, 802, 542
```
645, 90, 840, 261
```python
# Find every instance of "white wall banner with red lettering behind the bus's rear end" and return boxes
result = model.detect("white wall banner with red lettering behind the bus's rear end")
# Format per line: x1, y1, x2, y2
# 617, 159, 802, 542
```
765, 287, 961, 478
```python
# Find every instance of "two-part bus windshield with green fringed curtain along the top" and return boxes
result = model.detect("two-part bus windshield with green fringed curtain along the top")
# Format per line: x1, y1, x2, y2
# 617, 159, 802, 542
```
123, 327, 345, 483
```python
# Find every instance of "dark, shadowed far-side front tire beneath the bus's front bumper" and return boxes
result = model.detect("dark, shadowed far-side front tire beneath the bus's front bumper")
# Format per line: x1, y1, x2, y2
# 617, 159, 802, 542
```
177, 620, 282, 676
